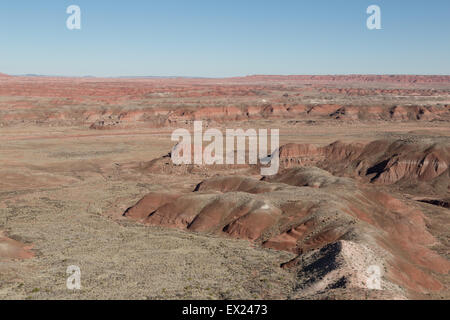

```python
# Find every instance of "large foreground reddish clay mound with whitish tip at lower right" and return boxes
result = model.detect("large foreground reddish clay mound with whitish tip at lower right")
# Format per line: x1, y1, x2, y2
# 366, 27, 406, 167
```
124, 168, 450, 295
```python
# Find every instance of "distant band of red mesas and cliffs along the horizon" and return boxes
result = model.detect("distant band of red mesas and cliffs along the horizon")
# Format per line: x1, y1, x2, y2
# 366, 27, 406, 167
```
0, 75, 450, 129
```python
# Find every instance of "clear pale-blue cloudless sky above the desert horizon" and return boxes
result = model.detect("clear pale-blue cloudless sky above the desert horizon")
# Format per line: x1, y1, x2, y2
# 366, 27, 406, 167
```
0, 0, 450, 77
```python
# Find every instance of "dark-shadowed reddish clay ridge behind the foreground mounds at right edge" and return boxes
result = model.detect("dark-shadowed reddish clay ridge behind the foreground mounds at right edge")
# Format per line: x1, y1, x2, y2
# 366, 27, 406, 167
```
280, 140, 450, 192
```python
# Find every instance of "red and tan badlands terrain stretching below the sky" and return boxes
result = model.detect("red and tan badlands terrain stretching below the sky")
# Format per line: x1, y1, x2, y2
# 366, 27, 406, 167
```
0, 74, 450, 299
